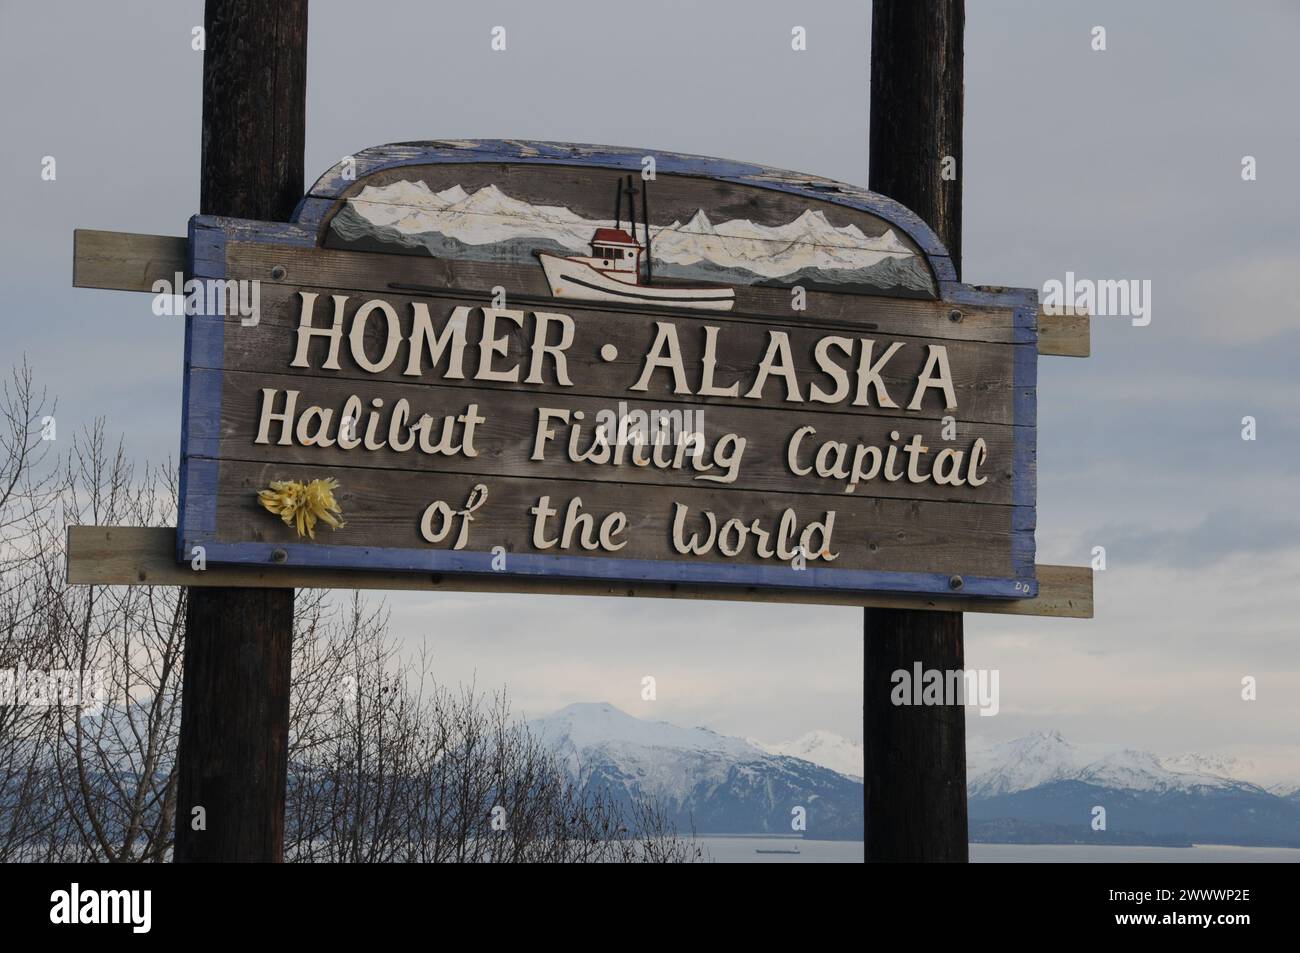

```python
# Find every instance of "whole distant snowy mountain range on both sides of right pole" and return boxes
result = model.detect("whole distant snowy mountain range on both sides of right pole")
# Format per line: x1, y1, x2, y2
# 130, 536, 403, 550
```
530, 703, 1300, 846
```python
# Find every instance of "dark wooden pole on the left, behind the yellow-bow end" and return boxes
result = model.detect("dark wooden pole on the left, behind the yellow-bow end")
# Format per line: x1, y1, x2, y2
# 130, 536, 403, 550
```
176, 0, 307, 862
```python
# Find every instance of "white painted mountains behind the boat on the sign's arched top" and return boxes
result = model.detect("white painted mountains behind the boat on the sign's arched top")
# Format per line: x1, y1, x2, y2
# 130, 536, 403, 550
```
330, 179, 932, 293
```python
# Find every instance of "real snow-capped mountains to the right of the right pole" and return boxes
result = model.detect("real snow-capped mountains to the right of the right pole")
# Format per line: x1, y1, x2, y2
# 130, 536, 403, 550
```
967, 732, 1300, 846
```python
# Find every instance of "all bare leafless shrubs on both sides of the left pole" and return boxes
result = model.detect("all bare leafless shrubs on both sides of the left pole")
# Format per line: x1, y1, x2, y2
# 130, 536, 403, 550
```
0, 365, 701, 863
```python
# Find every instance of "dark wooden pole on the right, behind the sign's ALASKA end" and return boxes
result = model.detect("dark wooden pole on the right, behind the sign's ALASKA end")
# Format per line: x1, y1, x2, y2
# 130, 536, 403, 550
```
862, 0, 969, 863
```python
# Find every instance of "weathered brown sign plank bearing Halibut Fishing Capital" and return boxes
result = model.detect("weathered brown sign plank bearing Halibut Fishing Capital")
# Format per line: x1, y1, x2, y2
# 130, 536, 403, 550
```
200, 361, 1036, 506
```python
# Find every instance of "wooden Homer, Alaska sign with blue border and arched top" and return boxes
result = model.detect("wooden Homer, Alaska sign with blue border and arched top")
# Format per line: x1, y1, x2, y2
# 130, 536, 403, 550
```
177, 142, 1037, 598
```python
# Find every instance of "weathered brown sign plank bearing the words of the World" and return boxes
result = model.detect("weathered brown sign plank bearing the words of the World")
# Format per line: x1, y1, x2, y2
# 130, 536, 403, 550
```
185, 460, 1034, 579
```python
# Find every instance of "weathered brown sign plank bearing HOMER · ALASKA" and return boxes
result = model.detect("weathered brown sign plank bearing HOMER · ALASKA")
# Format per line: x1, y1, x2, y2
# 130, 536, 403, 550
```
205, 273, 1035, 424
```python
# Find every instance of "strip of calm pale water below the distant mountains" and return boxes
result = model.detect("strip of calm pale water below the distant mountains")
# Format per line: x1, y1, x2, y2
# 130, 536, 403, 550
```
699, 837, 1300, 863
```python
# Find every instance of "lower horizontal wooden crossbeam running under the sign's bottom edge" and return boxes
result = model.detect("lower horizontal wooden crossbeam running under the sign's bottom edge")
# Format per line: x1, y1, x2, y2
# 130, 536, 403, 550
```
68, 527, 1092, 619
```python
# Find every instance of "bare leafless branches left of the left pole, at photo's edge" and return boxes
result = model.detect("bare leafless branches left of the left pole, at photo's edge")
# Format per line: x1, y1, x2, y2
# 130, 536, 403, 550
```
0, 413, 185, 861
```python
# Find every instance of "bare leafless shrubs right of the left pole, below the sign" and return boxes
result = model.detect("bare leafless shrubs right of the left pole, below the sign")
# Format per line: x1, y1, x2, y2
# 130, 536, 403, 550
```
286, 598, 701, 863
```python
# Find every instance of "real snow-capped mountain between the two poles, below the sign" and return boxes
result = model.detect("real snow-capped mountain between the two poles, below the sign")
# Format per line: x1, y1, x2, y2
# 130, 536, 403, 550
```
529, 702, 863, 840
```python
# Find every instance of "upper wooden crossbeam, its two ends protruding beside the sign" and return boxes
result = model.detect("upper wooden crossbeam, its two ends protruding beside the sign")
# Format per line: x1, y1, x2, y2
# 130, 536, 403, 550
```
73, 229, 1091, 358
